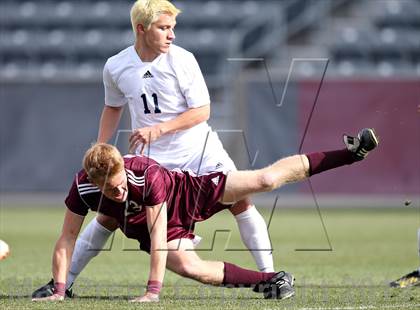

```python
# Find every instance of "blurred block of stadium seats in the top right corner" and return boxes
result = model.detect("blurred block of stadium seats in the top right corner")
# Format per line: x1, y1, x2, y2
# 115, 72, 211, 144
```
329, 0, 420, 75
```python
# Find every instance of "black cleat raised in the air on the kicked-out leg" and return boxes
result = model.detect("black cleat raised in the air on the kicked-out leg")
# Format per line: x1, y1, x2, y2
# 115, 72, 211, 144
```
343, 128, 379, 160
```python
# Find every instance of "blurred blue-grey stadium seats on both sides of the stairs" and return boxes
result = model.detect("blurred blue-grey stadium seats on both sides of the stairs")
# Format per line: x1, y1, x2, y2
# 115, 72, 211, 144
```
0, 0, 420, 84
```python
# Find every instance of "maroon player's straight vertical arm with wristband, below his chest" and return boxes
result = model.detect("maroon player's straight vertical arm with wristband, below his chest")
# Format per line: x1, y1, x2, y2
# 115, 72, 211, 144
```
131, 202, 168, 302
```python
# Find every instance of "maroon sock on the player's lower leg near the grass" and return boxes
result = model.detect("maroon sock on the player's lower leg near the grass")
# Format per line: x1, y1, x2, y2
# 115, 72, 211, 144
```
223, 262, 276, 287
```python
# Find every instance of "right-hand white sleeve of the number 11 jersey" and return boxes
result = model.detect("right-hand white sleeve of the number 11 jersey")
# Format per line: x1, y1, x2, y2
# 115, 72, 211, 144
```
178, 53, 210, 108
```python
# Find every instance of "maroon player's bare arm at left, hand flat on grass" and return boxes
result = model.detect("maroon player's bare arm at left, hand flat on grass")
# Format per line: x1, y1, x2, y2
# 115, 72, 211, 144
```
32, 209, 84, 301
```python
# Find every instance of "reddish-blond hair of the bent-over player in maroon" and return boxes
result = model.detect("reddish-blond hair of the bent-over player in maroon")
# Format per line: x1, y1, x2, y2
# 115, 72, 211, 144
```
83, 143, 124, 184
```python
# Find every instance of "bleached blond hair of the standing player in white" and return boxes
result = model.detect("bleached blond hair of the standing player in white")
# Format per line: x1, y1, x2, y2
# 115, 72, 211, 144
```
130, 0, 181, 36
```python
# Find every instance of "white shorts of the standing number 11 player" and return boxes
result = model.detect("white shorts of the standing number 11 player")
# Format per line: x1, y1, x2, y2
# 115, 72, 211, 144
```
153, 131, 237, 175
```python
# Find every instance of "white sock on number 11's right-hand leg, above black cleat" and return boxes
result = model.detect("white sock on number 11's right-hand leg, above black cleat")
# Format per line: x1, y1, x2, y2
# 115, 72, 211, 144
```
235, 206, 274, 272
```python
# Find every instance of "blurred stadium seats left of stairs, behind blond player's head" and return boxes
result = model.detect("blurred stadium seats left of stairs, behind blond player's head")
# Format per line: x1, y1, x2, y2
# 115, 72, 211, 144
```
0, 0, 279, 84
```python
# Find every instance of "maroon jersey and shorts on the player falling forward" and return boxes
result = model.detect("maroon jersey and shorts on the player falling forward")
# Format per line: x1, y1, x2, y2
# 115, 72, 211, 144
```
65, 156, 230, 252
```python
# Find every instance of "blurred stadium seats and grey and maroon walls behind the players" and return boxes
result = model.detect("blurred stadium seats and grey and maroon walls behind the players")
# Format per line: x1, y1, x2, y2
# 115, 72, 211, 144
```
0, 0, 420, 207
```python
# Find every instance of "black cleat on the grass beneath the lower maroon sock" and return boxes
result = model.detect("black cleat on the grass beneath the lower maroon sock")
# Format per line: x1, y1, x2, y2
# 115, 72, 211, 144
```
253, 271, 295, 299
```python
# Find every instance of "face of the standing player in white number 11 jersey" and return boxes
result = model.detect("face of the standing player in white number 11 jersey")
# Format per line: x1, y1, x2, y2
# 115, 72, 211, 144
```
144, 14, 176, 56
